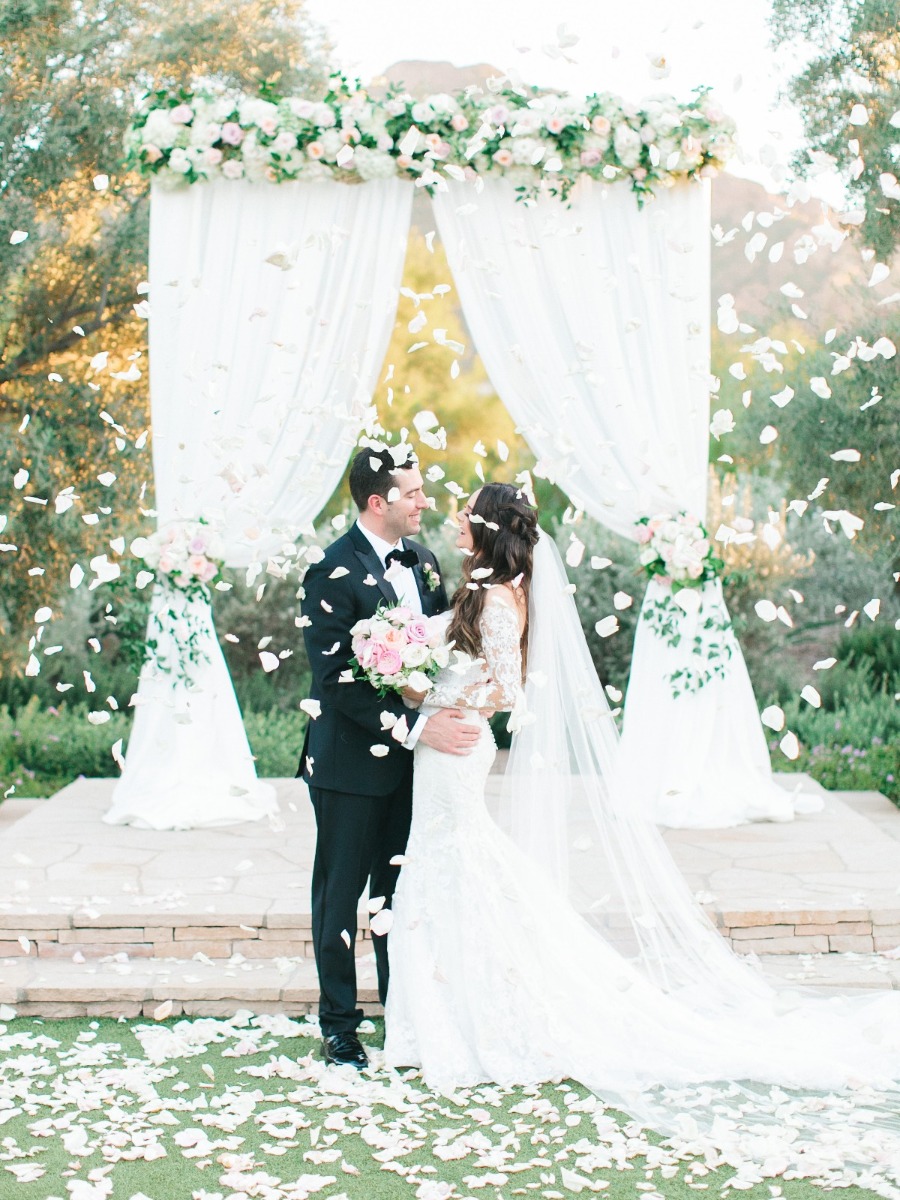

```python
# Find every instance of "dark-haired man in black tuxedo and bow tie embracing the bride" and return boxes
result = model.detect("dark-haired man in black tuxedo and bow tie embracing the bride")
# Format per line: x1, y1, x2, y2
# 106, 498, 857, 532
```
298, 449, 478, 1070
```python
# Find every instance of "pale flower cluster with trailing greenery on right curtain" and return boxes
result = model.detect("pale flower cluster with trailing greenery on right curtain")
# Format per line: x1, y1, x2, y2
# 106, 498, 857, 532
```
637, 512, 736, 698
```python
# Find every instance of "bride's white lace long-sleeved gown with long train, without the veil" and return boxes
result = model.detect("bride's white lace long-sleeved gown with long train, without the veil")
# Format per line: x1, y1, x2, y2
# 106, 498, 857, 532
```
385, 599, 900, 1195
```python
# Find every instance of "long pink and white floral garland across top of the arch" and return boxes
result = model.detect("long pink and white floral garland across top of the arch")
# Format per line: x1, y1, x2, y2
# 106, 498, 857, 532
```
125, 74, 734, 203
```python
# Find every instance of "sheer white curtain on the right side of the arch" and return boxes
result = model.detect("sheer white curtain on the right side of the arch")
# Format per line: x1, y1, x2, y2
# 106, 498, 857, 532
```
434, 179, 806, 827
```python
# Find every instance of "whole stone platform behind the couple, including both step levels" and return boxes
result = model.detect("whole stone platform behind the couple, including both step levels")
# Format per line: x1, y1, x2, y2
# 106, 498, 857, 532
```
0, 776, 900, 1016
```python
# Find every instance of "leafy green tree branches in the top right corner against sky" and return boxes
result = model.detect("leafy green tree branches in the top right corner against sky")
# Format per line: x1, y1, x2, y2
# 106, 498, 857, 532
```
770, 0, 900, 260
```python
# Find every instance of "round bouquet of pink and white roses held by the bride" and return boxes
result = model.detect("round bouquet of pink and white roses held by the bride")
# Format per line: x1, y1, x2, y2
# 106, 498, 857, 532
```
350, 604, 450, 696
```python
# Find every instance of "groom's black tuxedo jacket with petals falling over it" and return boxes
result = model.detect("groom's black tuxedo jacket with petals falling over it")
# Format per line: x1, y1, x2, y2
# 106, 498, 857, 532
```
298, 524, 448, 796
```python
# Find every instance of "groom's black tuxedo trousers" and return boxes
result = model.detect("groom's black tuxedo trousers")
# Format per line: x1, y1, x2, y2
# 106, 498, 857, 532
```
310, 772, 413, 1037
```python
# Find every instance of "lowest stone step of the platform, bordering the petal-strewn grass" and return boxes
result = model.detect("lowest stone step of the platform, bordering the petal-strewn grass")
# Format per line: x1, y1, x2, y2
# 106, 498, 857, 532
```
0, 954, 900, 1020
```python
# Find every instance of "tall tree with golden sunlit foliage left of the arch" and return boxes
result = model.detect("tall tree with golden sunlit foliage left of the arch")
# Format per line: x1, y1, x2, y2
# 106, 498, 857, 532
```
0, 0, 325, 686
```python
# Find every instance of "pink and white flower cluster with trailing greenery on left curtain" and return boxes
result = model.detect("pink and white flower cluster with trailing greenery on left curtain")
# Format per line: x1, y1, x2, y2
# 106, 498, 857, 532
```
130, 517, 230, 683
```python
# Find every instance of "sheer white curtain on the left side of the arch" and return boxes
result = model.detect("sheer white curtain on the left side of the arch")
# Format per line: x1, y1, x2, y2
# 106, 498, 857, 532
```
104, 179, 413, 828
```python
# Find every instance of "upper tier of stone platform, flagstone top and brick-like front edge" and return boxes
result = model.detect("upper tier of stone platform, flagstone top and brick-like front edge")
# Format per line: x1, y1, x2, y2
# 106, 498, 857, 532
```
0, 776, 900, 978
